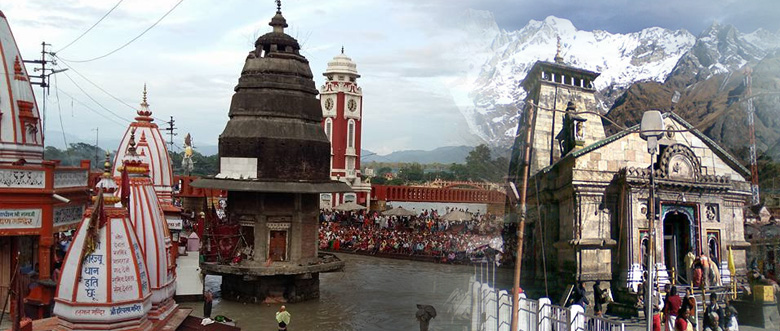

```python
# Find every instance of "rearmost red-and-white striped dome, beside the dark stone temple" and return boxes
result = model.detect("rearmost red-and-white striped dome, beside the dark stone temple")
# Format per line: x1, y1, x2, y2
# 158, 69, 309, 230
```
111, 85, 173, 205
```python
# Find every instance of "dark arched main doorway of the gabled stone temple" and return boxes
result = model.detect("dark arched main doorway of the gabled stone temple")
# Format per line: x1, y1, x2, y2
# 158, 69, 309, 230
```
664, 211, 693, 284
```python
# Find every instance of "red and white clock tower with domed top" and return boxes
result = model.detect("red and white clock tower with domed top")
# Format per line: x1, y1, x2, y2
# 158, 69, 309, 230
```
320, 47, 371, 207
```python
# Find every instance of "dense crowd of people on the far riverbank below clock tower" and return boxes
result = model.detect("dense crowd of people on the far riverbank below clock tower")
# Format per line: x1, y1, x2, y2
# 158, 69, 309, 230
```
319, 208, 512, 264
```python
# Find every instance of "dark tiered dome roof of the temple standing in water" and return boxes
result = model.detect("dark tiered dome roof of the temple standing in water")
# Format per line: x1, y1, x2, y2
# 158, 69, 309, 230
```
217, 10, 330, 182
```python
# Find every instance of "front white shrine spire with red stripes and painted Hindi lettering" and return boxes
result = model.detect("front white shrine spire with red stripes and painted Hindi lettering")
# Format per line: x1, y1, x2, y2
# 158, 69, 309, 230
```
54, 155, 152, 330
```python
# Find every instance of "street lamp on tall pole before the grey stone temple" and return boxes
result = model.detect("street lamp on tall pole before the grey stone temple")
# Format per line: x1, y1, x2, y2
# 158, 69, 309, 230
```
639, 110, 664, 331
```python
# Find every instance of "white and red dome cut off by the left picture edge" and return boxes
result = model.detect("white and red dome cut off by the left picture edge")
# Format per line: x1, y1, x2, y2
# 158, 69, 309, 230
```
0, 11, 43, 163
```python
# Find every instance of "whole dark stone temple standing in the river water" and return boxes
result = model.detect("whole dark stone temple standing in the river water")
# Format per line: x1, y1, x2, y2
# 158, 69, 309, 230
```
193, 3, 344, 302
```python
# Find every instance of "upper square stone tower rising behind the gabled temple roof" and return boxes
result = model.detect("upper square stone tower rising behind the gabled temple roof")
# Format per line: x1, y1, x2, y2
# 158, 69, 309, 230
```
509, 42, 606, 180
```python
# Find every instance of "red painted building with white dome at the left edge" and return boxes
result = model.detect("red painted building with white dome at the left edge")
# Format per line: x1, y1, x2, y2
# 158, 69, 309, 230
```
0, 12, 89, 317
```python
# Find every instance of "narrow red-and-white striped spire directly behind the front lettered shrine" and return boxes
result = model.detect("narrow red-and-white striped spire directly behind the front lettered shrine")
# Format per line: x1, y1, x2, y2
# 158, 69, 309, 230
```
119, 130, 176, 320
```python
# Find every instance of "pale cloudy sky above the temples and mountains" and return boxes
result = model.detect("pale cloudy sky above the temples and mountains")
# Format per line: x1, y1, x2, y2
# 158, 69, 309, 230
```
0, 0, 780, 154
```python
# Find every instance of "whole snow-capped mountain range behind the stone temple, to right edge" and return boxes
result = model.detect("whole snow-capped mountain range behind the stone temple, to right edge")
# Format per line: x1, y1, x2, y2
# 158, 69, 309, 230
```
449, 11, 780, 147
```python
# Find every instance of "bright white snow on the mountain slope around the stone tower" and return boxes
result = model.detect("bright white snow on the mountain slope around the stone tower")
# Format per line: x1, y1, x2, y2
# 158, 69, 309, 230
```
450, 11, 696, 146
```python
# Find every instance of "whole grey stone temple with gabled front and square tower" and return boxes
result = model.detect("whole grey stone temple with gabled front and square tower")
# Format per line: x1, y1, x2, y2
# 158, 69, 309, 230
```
509, 51, 750, 302
